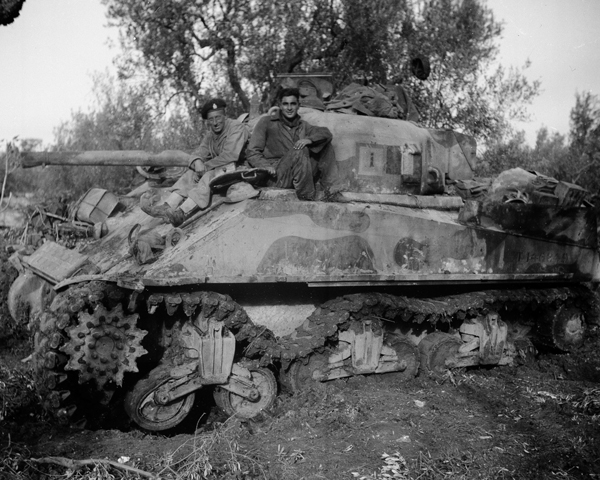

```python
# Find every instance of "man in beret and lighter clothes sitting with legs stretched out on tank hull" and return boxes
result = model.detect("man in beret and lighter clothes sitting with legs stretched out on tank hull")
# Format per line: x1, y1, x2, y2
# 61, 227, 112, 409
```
140, 98, 248, 227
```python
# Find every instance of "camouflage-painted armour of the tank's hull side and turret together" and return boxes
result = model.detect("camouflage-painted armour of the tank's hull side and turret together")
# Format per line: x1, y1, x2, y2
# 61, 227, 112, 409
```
47, 108, 599, 288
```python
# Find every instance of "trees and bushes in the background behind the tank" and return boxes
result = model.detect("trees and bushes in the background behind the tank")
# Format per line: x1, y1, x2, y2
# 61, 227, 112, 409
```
0, 0, 600, 195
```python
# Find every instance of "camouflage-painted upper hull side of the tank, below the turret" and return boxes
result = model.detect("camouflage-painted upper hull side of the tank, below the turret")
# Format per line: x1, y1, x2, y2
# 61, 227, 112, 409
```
76, 195, 599, 287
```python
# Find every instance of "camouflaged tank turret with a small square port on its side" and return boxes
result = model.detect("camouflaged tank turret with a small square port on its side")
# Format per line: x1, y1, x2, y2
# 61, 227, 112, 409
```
300, 109, 476, 194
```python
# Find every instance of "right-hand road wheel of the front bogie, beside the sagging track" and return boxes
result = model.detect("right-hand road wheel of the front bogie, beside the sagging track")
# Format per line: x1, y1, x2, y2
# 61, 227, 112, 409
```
213, 368, 277, 419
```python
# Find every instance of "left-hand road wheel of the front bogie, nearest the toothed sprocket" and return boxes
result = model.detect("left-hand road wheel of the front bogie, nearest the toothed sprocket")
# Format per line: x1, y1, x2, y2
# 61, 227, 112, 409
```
125, 366, 196, 432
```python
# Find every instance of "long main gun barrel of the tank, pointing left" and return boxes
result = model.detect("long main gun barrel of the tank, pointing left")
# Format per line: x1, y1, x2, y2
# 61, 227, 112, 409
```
21, 150, 192, 168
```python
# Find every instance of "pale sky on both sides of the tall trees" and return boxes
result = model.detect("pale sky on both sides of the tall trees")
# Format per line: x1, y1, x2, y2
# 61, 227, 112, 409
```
0, 0, 600, 147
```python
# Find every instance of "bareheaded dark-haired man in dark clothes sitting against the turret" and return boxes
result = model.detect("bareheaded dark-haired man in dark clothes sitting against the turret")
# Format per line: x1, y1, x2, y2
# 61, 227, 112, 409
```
246, 88, 337, 200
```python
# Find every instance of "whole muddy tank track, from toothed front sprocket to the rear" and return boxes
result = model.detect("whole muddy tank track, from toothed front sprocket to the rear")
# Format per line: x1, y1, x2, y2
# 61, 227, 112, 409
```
32, 282, 600, 426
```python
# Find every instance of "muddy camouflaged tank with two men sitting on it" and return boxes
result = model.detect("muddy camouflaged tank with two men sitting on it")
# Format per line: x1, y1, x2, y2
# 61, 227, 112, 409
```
11, 78, 600, 431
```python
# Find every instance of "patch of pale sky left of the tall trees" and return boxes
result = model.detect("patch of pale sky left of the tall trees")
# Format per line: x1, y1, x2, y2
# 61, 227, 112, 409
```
0, 0, 117, 143
